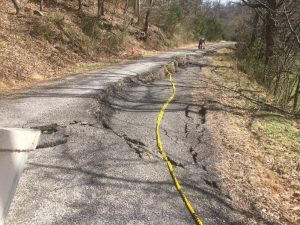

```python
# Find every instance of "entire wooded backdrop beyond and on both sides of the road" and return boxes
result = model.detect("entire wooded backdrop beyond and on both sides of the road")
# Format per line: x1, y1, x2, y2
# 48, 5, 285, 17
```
0, 0, 300, 112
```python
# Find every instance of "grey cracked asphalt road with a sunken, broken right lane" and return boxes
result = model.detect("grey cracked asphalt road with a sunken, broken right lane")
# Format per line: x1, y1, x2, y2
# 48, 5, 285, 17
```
0, 45, 241, 225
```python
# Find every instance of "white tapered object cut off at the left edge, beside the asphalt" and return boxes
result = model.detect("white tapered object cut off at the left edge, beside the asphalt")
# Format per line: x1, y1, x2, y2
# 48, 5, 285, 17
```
0, 127, 41, 225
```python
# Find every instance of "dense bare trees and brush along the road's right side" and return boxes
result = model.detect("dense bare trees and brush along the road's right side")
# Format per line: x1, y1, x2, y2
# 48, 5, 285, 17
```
237, 0, 300, 112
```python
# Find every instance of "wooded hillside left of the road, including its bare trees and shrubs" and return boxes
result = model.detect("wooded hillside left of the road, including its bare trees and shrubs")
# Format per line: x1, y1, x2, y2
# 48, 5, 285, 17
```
0, 0, 223, 93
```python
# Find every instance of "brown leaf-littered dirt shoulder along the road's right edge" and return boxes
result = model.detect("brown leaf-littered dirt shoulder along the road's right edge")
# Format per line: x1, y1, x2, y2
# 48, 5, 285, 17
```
194, 49, 300, 225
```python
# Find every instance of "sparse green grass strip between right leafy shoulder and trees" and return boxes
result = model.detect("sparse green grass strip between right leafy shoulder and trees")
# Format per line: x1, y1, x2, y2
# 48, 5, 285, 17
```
207, 47, 300, 190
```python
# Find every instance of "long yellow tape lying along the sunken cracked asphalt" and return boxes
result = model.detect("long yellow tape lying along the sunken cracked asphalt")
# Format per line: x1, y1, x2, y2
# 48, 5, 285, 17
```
156, 67, 203, 225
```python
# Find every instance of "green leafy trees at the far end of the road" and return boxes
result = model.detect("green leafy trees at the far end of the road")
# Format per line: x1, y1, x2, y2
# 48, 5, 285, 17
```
153, 1, 224, 42
